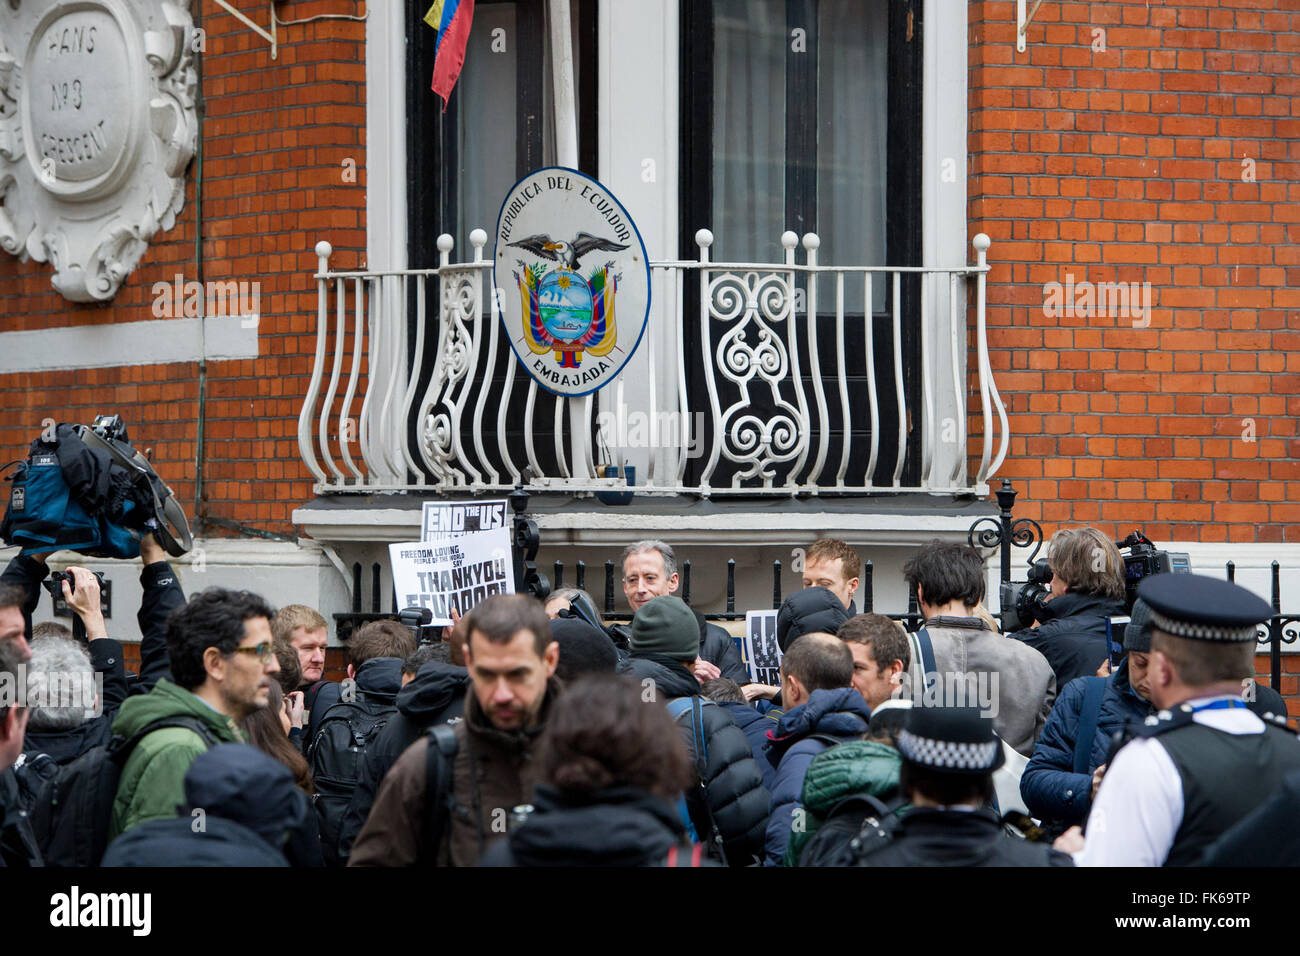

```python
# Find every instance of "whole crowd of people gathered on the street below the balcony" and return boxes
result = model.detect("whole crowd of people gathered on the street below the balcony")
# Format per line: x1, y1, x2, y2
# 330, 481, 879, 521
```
0, 528, 1300, 866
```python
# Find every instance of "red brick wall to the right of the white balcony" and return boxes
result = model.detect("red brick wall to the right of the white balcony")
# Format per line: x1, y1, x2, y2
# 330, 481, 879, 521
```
969, 0, 1300, 541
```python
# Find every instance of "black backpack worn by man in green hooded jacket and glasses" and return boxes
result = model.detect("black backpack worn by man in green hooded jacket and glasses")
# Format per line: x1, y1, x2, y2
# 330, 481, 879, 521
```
30, 714, 220, 866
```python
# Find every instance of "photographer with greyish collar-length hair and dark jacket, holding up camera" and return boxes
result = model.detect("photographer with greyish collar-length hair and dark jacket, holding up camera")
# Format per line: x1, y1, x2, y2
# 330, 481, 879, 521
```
1002, 527, 1126, 688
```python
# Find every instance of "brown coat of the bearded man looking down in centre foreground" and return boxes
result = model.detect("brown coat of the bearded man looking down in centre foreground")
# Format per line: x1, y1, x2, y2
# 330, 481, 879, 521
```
347, 678, 562, 866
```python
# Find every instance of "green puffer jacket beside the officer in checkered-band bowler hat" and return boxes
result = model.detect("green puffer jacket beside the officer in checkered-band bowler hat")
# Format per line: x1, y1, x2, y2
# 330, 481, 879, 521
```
785, 740, 902, 866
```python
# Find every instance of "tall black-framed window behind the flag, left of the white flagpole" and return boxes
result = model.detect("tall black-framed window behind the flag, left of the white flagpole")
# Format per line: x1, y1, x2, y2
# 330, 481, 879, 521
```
407, 0, 597, 475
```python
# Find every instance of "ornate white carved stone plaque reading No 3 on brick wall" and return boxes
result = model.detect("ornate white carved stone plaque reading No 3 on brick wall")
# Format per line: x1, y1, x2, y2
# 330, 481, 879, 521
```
0, 0, 199, 302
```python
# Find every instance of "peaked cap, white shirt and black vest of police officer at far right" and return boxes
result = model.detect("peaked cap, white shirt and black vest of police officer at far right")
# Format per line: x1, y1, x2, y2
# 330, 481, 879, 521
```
1075, 575, 1300, 866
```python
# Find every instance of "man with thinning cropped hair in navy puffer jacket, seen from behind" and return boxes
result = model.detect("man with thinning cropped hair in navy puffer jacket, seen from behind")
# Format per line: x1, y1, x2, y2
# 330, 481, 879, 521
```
764, 633, 871, 866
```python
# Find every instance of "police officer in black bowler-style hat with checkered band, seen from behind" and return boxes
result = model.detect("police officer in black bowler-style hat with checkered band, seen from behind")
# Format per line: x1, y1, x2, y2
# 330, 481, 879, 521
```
823, 708, 1071, 866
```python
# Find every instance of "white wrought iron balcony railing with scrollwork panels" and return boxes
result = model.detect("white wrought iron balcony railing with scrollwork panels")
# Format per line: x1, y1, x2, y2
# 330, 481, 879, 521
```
298, 229, 1009, 496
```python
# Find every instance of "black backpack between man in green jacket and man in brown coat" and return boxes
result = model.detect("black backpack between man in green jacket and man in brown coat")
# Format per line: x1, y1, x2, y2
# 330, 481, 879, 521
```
307, 691, 398, 866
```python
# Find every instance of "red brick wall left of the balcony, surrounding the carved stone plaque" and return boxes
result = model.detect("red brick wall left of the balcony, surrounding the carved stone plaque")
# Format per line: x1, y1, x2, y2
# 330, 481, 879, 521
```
0, 0, 365, 533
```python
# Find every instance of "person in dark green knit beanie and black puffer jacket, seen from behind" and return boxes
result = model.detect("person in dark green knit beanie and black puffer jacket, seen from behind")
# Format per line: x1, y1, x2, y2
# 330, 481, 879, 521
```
628, 596, 771, 866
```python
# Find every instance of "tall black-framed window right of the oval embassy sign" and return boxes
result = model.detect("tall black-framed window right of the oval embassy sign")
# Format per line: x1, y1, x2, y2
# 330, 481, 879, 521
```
680, 0, 922, 484
